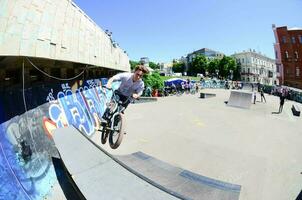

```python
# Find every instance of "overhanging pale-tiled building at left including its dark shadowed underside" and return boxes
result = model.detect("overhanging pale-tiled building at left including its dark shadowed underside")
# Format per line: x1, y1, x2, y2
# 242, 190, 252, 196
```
0, 0, 130, 86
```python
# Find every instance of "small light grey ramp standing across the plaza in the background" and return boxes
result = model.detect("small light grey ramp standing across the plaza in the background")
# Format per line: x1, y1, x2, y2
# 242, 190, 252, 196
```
227, 90, 252, 109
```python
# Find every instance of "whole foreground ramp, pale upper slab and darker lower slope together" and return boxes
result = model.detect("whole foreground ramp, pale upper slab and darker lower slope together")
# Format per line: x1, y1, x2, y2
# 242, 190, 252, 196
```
53, 126, 241, 200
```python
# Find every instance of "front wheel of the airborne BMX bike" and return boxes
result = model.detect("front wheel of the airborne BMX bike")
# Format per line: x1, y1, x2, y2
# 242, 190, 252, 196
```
109, 113, 124, 149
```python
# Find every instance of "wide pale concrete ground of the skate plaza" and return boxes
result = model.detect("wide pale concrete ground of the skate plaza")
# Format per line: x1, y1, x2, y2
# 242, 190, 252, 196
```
95, 89, 302, 200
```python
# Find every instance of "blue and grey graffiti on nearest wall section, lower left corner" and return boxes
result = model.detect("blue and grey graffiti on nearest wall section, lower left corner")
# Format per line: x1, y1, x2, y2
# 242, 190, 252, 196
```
0, 105, 57, 199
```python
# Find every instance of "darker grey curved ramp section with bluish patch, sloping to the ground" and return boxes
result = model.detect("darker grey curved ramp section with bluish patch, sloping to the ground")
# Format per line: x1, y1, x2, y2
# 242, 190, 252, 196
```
118, 152, 241, 200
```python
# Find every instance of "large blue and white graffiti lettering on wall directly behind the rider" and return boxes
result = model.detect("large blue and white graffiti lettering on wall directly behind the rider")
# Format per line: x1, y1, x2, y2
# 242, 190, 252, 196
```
44, 80, 119, 136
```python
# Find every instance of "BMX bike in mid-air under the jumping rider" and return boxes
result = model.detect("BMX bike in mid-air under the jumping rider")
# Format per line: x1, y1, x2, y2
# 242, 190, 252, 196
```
100, 87, 131, 149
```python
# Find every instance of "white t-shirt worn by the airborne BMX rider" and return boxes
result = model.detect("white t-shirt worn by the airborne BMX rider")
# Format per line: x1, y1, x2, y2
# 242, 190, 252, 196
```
113, 72, 145, 97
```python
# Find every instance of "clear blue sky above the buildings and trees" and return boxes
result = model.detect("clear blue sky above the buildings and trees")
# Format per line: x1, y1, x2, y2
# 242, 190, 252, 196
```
74, 0, 302, 62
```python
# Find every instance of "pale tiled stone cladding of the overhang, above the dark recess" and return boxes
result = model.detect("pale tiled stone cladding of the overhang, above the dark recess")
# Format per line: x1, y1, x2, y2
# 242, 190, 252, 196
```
0, 0, 130, 71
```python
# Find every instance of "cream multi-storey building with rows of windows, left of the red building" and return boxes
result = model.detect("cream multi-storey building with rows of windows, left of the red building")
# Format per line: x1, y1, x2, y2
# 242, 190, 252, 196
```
231, 49, 278, 85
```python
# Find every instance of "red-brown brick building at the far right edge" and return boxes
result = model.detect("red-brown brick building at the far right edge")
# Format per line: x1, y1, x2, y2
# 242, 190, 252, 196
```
272, 25, 302, 89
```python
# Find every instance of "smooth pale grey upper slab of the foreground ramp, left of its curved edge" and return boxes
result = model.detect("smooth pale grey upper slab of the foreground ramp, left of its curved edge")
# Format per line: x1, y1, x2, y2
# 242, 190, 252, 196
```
53, 126, 178, 200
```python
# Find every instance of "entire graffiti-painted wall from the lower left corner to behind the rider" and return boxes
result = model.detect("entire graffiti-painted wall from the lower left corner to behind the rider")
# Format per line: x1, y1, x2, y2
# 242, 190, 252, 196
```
0, 77, 119, 200
